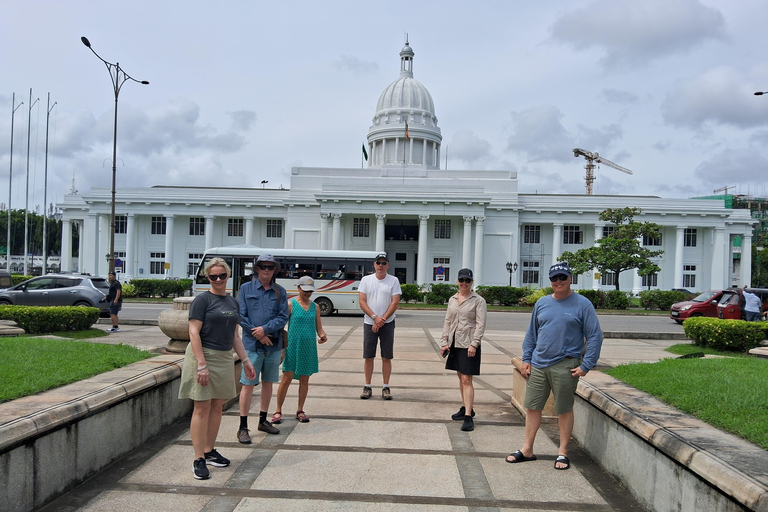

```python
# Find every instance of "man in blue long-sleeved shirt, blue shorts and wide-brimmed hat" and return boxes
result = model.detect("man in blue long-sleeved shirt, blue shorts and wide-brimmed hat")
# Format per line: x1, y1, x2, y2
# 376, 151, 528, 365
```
237, 254, 288, 444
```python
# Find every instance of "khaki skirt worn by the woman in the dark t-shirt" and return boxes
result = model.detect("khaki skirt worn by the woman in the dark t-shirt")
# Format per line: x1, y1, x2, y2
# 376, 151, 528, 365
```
179, 343, 237, 401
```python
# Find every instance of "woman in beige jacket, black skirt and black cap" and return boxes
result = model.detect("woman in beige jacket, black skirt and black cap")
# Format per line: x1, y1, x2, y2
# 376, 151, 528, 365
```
440, 268, 488, 431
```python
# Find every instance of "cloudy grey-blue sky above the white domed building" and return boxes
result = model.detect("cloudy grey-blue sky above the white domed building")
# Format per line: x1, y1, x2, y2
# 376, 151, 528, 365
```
0, 0, 768, 209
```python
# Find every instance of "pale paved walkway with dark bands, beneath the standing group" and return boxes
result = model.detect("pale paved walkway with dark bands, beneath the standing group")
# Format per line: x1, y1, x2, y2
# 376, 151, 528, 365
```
41, 326, 679, 512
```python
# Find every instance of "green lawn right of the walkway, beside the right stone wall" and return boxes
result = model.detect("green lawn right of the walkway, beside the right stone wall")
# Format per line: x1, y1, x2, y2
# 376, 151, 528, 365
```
604, 345, 768, 450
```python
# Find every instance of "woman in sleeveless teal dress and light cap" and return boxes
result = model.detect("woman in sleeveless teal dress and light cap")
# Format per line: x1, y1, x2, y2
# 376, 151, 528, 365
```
272, 276, 328, 423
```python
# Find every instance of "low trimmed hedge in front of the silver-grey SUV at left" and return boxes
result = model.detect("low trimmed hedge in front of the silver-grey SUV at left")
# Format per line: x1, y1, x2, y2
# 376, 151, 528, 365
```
0, 306, 99, 334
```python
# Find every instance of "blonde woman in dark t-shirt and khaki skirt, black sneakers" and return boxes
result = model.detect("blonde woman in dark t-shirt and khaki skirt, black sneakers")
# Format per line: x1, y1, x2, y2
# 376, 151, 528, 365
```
179, 258, 256, 480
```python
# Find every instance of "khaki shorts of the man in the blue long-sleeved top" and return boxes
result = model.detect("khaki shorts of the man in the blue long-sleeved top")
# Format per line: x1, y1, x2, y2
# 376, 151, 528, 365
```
523, 357, 581, 416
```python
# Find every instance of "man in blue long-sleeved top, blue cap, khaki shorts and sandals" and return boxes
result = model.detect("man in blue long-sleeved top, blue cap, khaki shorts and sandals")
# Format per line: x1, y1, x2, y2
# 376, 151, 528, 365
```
507, 262, 603, 470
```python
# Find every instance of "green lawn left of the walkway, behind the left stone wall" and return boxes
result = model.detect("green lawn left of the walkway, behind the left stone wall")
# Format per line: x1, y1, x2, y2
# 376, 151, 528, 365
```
0, 336, 155, 402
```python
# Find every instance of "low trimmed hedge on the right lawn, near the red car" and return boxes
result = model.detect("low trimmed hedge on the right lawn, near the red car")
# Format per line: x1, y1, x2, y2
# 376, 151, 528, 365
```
683, 317, 768, 352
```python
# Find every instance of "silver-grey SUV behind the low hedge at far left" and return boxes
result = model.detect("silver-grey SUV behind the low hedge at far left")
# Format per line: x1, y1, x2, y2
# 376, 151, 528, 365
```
0, 274, 109, 314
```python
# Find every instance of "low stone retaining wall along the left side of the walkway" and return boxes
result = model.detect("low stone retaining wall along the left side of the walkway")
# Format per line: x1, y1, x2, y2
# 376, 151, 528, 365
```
0, 355, 240, 512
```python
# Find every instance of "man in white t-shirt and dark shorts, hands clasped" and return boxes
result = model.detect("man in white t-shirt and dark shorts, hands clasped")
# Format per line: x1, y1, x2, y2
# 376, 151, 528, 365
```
358, 253, 403, 400
